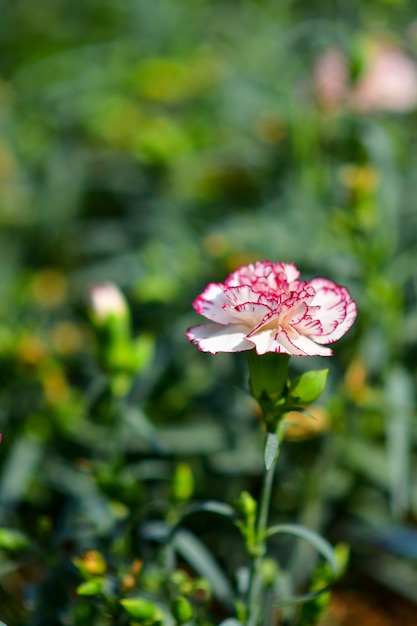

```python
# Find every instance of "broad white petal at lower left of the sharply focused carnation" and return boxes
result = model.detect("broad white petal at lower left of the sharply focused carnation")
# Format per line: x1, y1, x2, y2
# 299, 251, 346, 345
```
186, 323, 253, 354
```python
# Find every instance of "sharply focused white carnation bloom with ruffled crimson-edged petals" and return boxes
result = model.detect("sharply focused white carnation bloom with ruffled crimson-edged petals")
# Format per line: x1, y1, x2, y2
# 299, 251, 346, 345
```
187, 261, 357, 356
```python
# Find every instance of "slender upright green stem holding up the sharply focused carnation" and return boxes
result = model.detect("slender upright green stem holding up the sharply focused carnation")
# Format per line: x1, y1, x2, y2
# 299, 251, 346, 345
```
247, 436, 279, 626
